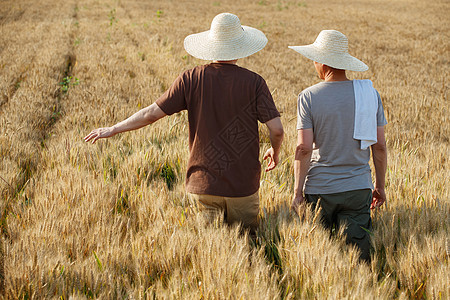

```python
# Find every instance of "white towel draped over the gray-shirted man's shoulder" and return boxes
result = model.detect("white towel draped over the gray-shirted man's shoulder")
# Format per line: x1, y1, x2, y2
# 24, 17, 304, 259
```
353, 79, 378, 149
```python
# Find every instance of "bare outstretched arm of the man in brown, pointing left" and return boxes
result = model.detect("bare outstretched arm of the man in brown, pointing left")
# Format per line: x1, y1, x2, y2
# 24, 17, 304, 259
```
84, 103, 166, 144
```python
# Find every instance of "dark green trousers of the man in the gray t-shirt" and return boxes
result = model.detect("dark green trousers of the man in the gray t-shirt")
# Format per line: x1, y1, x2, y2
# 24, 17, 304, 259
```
305, 189, 372, 261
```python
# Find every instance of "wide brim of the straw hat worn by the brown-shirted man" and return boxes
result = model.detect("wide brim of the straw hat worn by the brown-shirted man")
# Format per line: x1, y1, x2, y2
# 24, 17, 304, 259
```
184, 26, 267, 60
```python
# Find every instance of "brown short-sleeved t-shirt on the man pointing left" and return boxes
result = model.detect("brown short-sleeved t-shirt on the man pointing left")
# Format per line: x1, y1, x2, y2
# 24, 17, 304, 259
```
156, 63, 280, 197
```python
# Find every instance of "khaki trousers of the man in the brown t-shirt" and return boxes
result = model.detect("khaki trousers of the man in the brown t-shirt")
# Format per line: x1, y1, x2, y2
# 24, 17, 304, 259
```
188, 191, 259, 232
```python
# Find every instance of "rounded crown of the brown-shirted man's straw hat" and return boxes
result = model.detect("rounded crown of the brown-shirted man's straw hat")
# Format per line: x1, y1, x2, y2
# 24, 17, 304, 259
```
209, 13, 244, 41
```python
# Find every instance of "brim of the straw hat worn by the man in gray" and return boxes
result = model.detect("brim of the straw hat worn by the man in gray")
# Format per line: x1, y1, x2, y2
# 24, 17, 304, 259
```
288, 44, 369, 72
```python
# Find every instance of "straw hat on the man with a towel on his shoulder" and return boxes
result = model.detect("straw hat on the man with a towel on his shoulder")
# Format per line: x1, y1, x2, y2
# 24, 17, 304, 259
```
289, 30, 369, 72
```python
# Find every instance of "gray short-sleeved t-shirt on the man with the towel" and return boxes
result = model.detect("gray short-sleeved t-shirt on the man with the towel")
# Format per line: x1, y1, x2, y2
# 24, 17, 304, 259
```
297, 80, 387, 194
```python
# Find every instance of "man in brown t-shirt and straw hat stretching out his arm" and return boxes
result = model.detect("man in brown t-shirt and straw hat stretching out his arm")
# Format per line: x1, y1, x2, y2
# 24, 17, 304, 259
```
85, 13, 284, 229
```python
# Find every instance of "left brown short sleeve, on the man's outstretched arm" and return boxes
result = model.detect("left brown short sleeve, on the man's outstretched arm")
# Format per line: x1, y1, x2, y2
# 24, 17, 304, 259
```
156, 74, 187, 115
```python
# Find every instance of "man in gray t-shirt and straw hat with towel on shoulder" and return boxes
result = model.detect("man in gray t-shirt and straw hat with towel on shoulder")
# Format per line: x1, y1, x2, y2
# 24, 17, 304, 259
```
290, 30, 387, 261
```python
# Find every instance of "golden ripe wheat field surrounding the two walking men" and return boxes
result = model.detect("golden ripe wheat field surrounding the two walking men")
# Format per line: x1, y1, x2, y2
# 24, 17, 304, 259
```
0, 0, 450, 299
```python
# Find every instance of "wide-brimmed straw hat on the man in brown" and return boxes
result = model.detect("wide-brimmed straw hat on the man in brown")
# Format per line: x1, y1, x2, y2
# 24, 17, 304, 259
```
184, 13, 267, 60
